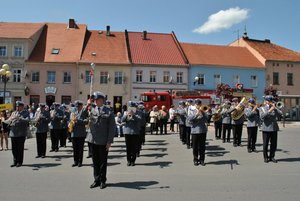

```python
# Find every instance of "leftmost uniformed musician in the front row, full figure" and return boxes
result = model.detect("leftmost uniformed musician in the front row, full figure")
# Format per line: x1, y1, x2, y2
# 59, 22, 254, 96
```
6, 101, 30, 167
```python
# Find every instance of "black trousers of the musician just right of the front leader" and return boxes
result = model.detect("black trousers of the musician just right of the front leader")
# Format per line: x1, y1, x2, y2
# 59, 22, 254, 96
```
125, 134, 139, 163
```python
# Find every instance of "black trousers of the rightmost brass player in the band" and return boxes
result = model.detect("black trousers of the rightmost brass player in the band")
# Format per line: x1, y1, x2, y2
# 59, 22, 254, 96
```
263, 131, 277, 159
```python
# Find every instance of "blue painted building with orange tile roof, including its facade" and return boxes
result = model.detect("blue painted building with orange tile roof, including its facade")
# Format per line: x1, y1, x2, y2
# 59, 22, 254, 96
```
181, 43, 265, 102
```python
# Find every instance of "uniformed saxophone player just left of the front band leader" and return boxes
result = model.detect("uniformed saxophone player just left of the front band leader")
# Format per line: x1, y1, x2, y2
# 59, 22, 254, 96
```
69, 100, 88, 167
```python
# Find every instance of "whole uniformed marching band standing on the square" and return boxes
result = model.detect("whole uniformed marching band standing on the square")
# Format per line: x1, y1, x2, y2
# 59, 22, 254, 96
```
1, 91, 283, 189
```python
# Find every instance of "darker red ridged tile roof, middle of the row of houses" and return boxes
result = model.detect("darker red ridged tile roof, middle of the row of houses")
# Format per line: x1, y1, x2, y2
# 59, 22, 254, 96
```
128, 32, 186, 65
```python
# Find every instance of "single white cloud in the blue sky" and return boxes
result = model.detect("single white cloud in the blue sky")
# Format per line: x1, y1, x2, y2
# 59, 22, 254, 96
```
193, 7, 249, 34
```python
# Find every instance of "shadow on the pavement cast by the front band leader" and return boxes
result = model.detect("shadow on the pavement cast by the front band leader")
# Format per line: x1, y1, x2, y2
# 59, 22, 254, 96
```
107, 181, 170, 190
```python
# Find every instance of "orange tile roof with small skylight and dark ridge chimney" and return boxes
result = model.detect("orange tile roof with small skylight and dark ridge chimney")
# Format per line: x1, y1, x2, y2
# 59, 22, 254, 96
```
28, 23, 87, 62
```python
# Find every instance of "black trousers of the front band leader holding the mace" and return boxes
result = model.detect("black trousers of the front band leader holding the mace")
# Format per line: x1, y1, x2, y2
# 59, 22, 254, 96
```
91, 143, 108, 183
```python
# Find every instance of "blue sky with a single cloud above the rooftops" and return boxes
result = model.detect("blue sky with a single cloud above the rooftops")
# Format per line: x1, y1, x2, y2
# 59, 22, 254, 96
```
0, 0, 300, 52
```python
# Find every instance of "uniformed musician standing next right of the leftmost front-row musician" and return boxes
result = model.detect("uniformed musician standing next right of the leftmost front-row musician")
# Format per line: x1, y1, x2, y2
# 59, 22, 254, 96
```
34, 103, 50, 158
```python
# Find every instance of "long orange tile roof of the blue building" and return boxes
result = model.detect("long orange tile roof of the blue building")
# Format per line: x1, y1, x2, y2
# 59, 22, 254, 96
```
180, 43, 264, 68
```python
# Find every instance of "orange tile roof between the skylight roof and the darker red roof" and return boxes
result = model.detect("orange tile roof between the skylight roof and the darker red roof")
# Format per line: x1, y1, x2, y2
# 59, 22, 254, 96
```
80, 31, 129, 64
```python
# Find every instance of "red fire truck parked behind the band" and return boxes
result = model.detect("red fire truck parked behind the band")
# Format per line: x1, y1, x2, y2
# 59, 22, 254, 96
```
141, 91, 211, 111
